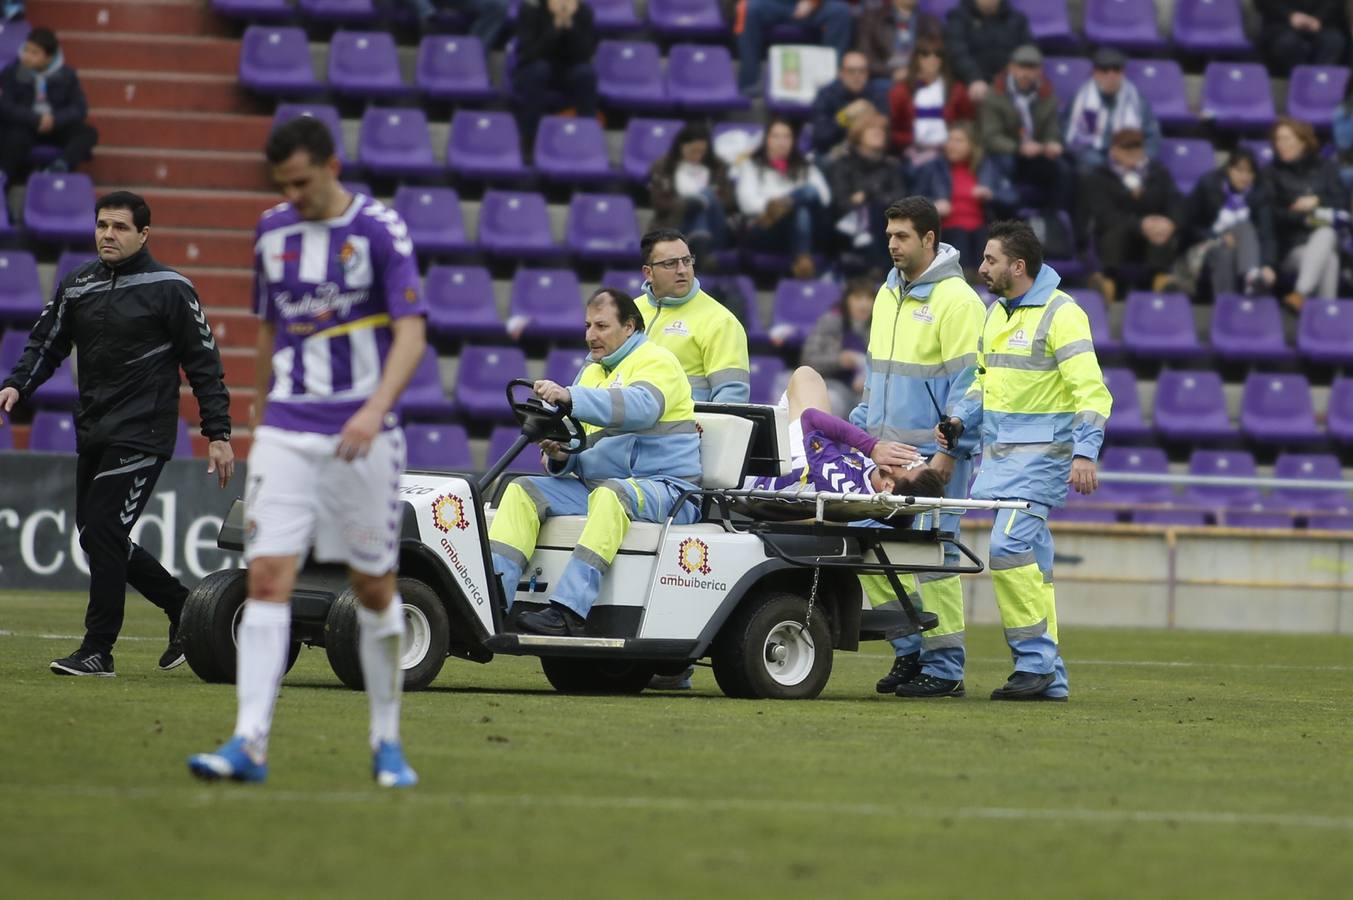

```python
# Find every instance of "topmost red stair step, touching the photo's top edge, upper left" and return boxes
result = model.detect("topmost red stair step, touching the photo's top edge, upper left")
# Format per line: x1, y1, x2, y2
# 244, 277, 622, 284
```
28, 0, 234, 38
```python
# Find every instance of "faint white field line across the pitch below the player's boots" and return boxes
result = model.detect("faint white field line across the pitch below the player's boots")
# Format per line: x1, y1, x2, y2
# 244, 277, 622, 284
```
0, 785, 1353, 831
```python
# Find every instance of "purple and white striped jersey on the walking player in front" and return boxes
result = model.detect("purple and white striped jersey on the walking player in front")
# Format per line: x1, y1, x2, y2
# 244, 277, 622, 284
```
254, 194, 426, 434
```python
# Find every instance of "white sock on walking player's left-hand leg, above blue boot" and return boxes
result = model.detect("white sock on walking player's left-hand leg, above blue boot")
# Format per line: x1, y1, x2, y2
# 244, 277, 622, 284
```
235, 600, 291, 759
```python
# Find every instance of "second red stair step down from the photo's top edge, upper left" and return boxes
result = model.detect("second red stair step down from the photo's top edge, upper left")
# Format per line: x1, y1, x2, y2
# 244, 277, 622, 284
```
60, 31, 239, 77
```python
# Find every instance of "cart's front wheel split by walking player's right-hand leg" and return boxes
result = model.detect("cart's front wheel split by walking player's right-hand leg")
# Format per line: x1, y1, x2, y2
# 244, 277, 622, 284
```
325, 578, 451, 692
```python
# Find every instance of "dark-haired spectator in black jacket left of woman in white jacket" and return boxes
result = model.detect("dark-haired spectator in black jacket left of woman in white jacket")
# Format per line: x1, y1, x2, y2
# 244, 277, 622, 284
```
648, 122, 733, 268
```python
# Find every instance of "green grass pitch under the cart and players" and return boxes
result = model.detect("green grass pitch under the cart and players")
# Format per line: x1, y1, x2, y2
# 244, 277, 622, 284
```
0, 591, 1353, 900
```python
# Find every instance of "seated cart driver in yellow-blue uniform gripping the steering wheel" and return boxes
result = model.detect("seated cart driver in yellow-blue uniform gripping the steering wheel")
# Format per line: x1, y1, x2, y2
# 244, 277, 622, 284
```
488, 287, 701, 636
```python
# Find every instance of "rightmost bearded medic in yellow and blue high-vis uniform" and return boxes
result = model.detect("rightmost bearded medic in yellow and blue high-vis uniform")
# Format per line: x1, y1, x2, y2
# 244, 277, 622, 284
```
955, 222, 1114, 700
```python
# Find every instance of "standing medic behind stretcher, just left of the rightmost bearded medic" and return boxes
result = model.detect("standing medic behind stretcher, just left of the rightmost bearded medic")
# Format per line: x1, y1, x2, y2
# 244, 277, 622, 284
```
850, 228, 982, 697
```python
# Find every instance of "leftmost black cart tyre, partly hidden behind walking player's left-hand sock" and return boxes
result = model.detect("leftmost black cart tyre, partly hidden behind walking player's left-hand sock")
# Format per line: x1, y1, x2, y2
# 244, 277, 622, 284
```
179, 568, 300, 685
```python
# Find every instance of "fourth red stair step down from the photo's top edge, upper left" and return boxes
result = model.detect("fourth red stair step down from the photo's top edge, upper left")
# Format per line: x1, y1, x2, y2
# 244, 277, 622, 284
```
89, 110, 272, 153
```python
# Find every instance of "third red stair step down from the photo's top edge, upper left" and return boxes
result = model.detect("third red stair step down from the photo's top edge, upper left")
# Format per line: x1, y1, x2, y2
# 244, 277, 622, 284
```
80, 70, 267, 114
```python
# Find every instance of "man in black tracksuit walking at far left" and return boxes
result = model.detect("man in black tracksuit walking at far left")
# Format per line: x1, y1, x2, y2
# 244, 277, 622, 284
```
0, 191, 234, 675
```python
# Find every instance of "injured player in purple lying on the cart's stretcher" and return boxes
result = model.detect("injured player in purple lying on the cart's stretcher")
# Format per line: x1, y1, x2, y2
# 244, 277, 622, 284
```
746, 365, 944, 497
